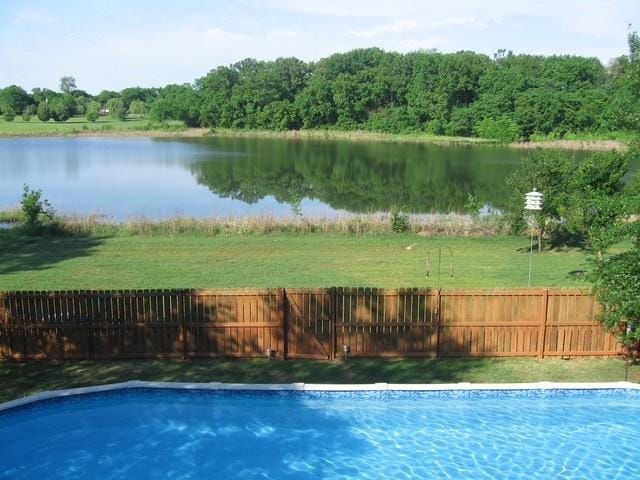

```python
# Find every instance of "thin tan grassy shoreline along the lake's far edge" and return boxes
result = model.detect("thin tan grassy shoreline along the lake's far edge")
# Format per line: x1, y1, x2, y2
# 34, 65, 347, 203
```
0, 128, 628, 151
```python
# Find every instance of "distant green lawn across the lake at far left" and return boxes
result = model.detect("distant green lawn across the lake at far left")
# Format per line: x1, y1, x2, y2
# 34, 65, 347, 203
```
0, 116, 182, 137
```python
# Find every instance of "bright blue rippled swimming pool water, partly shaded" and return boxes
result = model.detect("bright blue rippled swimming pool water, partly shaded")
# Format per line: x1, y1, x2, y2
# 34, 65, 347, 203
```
0, 389, 640, 480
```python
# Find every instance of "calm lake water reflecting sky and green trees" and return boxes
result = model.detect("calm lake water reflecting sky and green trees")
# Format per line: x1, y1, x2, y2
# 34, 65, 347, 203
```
0, 138, 596, 219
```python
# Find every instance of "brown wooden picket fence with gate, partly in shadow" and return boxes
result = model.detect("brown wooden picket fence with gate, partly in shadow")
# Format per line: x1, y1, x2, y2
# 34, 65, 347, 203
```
0, 288, 621, 359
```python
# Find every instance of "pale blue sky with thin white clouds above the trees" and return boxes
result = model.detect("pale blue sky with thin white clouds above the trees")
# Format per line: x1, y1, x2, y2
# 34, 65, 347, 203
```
0, 0, 640, 93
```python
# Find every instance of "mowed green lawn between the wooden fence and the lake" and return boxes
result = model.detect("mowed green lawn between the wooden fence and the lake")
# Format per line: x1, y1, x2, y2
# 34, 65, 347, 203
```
0, 231, 589, 291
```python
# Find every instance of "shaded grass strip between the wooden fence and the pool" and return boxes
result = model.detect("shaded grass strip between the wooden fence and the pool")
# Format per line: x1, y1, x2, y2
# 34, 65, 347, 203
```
0, 359, 640, 402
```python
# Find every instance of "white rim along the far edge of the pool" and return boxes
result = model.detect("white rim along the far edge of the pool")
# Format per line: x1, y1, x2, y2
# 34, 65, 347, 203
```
0, 380, 640, 412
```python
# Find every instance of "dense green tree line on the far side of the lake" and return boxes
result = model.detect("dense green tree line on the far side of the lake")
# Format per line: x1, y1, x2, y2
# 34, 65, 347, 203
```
0, 32, 640, 141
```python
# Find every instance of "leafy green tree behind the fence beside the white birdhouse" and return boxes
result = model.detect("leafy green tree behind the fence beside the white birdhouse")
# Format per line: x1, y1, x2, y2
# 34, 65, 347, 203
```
506, 148, 640, 260
